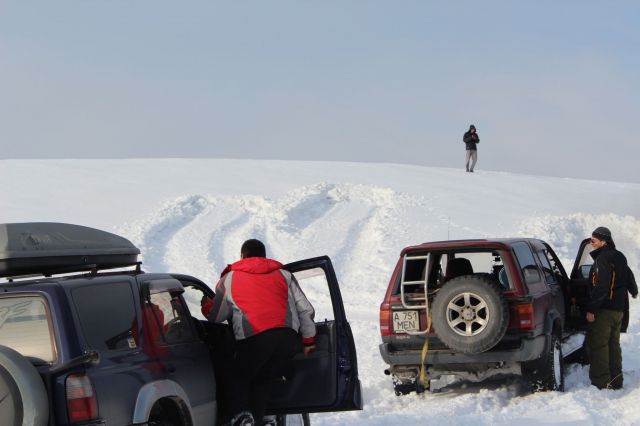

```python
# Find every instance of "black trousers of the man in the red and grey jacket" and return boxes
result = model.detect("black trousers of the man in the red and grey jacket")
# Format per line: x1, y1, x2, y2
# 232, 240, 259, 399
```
230, 328, 300, 425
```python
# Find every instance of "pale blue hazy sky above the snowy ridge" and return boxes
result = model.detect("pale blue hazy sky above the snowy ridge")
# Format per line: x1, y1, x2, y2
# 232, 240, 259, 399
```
0, 0, 640, 182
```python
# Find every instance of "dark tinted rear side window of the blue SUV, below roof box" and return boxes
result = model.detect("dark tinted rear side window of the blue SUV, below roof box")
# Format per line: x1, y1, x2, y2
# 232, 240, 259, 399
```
71, 281, 136, 351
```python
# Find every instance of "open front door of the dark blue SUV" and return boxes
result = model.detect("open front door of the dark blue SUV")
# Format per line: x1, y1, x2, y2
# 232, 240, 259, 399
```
267, 256, 362, 414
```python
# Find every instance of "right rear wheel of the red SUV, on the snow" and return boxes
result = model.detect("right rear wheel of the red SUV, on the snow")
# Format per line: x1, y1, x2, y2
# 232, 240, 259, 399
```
523, 334, 564, 392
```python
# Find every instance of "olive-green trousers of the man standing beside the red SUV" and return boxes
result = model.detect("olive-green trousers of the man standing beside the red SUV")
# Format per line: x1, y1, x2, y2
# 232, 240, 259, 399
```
587, 309, 623, 389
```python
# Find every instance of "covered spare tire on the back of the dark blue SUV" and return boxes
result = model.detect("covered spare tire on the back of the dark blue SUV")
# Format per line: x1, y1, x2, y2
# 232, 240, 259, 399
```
0, 345, 49, 426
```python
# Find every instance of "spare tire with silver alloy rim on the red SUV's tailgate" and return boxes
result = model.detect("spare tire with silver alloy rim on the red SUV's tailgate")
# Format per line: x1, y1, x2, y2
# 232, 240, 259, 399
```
431, 275, 509, 354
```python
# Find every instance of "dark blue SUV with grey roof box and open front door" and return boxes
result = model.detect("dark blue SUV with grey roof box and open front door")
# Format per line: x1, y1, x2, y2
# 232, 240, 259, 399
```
0, 223, 362, 426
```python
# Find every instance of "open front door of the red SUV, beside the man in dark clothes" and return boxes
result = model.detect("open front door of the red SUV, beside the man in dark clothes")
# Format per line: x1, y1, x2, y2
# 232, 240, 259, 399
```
569, 238, 593, 330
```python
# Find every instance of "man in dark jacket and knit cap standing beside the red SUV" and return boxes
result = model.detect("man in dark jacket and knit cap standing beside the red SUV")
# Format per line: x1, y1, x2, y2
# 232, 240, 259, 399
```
586, 226, 638, 389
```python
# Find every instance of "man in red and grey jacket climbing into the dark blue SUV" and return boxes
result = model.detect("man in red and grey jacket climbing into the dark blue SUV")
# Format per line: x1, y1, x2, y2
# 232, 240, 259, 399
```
203, 239, 316, 426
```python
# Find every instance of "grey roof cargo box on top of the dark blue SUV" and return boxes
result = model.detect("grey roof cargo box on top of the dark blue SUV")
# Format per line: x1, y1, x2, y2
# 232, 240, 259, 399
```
0, 222, 140, 277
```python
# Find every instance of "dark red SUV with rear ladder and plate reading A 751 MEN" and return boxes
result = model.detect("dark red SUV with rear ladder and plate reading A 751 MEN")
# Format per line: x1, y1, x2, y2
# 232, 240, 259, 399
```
380, 238, 592, 395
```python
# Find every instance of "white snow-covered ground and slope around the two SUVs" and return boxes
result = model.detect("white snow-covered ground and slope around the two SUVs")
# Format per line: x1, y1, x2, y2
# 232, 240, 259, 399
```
0, 159, 640, 425
